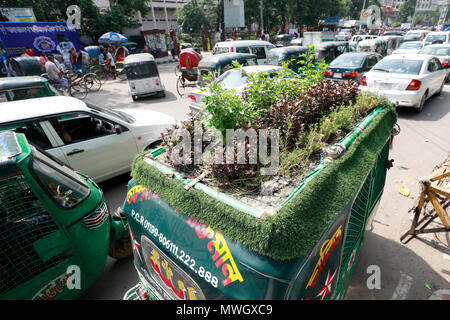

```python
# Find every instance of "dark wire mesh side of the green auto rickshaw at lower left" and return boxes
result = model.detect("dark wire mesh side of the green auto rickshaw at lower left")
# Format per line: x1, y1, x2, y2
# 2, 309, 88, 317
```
0, 173, 71, 294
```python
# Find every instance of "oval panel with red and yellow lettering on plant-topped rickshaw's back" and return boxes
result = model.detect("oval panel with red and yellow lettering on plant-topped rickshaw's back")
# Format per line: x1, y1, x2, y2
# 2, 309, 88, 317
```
141, 236, 205, 300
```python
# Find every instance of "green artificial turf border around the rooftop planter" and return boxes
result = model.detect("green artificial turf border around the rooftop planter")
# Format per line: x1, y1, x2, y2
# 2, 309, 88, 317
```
131, 107, 397, 260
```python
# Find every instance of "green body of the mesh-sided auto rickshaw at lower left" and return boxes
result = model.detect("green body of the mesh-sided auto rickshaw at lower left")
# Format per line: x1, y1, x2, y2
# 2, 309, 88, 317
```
0, 132, 127, 300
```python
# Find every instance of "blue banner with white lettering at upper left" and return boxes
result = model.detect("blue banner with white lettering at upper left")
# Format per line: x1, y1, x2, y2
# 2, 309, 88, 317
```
0, 22, 83, 57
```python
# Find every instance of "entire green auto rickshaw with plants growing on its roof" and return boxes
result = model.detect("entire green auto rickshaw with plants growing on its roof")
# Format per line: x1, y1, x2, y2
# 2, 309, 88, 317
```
120, 48, 396, 300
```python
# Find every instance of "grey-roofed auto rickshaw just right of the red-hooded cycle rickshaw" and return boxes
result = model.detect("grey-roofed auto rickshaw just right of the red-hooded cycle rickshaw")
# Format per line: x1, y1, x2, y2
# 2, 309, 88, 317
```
197, 52, 258, 86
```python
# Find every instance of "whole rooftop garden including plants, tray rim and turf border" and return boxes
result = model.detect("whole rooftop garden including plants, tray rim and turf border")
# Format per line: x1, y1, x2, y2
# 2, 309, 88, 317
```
132, 50, 397, 260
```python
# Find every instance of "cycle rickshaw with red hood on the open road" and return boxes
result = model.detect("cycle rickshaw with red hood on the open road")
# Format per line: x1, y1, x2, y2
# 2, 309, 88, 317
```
177, 48, 202, 97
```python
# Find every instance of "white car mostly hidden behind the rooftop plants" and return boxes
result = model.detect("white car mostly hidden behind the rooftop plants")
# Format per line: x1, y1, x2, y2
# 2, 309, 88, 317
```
189, 65, 298, 115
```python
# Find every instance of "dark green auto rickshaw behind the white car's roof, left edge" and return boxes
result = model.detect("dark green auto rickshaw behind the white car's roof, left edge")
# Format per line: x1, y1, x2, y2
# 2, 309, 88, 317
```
0, 76, 61, 102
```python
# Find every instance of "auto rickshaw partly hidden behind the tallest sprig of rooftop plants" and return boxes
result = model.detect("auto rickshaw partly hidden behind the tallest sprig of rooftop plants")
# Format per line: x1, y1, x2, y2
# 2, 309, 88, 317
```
267, 46, 309, 73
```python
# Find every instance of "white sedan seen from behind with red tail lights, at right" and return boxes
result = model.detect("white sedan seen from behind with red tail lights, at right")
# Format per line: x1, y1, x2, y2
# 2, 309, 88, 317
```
359, 54, 446, 112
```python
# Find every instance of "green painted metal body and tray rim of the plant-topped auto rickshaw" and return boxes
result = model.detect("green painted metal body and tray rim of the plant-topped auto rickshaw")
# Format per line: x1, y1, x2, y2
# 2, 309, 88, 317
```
124, 109, 398, 300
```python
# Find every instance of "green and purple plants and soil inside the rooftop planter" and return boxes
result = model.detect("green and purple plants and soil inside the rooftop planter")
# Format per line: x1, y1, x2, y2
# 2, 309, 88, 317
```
159, 48, 396, 208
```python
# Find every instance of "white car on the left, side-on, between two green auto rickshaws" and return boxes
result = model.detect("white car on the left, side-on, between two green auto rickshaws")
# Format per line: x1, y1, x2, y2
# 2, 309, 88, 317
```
0, 96, 176, 182
